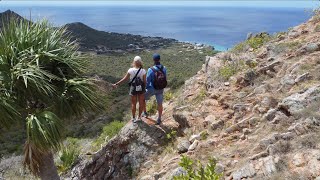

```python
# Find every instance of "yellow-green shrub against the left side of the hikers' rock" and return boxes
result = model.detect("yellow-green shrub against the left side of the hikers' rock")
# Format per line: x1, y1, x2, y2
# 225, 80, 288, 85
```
93, 121, 125, 150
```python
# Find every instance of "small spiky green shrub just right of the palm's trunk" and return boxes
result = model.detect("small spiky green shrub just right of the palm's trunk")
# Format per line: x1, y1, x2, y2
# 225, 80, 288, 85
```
56, 138, 80, 173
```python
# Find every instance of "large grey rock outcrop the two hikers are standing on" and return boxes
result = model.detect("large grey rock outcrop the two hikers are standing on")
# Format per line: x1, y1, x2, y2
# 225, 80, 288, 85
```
70, 119, 170, 179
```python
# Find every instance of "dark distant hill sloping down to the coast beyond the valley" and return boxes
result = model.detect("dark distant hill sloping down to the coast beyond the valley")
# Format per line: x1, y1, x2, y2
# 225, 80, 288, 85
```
65, 22, 177, 54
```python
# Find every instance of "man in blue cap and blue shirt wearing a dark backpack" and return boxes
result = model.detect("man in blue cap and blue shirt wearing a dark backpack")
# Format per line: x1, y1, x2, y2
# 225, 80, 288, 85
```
142, 54, 167, 125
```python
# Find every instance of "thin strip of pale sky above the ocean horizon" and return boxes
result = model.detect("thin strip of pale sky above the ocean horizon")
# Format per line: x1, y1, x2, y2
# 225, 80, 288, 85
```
0, 0, 320, 8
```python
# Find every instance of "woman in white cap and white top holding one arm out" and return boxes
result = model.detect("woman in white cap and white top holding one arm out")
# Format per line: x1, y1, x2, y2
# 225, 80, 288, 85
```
113, 56, 146, 123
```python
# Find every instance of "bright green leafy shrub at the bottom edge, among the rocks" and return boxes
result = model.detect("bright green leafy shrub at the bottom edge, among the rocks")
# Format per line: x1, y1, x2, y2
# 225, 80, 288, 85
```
173, 156, 222, 180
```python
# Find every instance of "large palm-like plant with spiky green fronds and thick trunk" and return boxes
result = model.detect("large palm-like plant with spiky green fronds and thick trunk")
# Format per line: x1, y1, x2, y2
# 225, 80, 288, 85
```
0, 19, 100, 179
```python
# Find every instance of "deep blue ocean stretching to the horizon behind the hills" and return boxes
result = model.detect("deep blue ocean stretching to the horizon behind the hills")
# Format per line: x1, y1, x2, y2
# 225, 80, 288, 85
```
0, 2, 311, 50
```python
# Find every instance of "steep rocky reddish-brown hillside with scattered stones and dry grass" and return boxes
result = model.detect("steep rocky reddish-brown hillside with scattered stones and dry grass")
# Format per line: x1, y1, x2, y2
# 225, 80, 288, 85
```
68, 14, 320, 180
